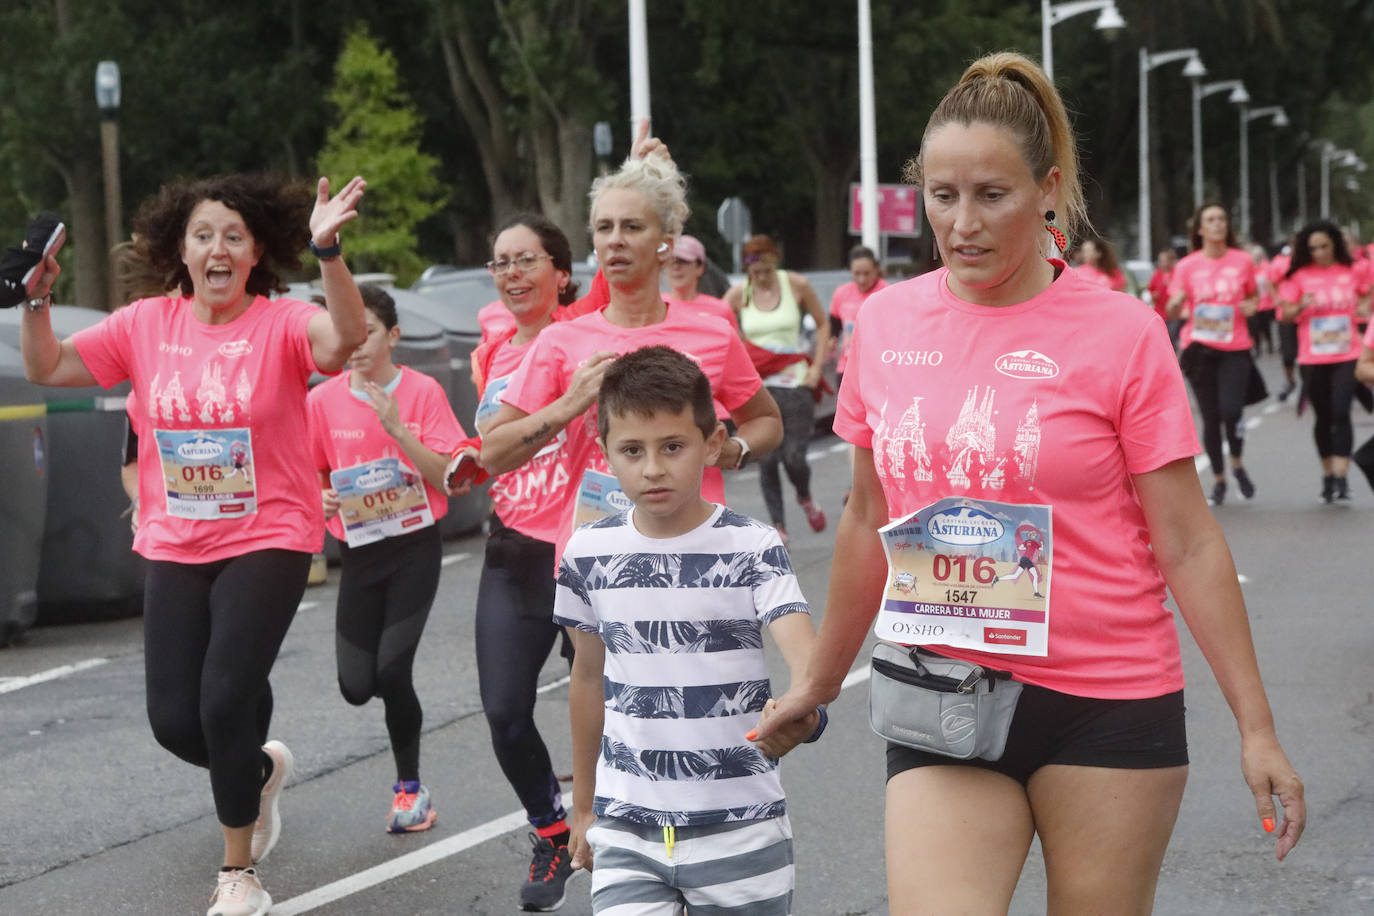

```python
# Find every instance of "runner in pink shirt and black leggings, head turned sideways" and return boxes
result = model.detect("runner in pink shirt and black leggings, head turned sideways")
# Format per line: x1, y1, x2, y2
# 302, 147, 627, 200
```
306, 283, 463, 834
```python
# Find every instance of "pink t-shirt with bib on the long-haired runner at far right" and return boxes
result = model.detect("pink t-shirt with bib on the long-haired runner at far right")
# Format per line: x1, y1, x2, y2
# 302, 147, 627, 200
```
1279, 264, 1369, 365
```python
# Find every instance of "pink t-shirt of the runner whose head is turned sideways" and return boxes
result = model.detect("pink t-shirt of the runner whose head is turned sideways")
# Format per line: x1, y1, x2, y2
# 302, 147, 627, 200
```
305, 367, 467, 541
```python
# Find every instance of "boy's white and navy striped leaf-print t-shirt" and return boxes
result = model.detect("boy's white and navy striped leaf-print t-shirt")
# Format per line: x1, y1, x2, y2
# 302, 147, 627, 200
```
554, 505, 809, 827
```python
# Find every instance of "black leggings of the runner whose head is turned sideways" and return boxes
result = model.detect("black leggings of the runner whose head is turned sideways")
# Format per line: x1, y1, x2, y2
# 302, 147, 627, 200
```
334, 525, 444, 781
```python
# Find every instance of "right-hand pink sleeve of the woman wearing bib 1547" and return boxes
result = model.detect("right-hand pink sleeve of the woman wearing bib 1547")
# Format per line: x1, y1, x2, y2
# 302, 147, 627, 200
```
1116, 316, 1198, 474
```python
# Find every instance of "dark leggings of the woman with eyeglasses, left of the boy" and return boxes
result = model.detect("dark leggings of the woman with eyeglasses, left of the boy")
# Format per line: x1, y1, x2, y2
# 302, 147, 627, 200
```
477, 515, 573, 834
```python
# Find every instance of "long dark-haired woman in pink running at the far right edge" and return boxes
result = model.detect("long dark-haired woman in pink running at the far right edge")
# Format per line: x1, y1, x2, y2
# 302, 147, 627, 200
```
1279, 220, 1370, 503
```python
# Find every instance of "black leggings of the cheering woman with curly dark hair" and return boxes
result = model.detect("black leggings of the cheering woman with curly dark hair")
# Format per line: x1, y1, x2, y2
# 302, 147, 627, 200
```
143, 549, 311, 827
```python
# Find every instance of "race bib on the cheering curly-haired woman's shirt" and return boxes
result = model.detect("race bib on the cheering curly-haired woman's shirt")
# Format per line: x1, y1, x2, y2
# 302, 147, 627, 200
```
153, 428, 257, 520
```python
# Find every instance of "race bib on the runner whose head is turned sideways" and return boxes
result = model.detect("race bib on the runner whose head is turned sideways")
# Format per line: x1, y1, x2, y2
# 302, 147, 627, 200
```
330, 457, 434, 547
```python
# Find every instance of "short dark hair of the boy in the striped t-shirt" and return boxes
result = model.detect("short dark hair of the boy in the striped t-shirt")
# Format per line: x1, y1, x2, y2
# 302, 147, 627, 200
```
596, 346, 716, 441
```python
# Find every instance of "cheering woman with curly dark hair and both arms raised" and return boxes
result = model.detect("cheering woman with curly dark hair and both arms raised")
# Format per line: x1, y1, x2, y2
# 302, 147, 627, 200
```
22, 174, 367, 916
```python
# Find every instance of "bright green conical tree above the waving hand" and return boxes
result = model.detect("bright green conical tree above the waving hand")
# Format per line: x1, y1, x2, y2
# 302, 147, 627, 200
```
317, 25, 444, 286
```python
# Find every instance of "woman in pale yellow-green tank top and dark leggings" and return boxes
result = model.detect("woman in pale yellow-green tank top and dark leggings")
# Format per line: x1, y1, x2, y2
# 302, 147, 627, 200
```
725, 235, 830, 545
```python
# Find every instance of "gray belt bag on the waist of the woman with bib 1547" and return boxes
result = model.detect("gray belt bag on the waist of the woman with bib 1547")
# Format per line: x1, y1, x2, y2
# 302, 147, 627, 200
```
868, 643, 1021, 761
